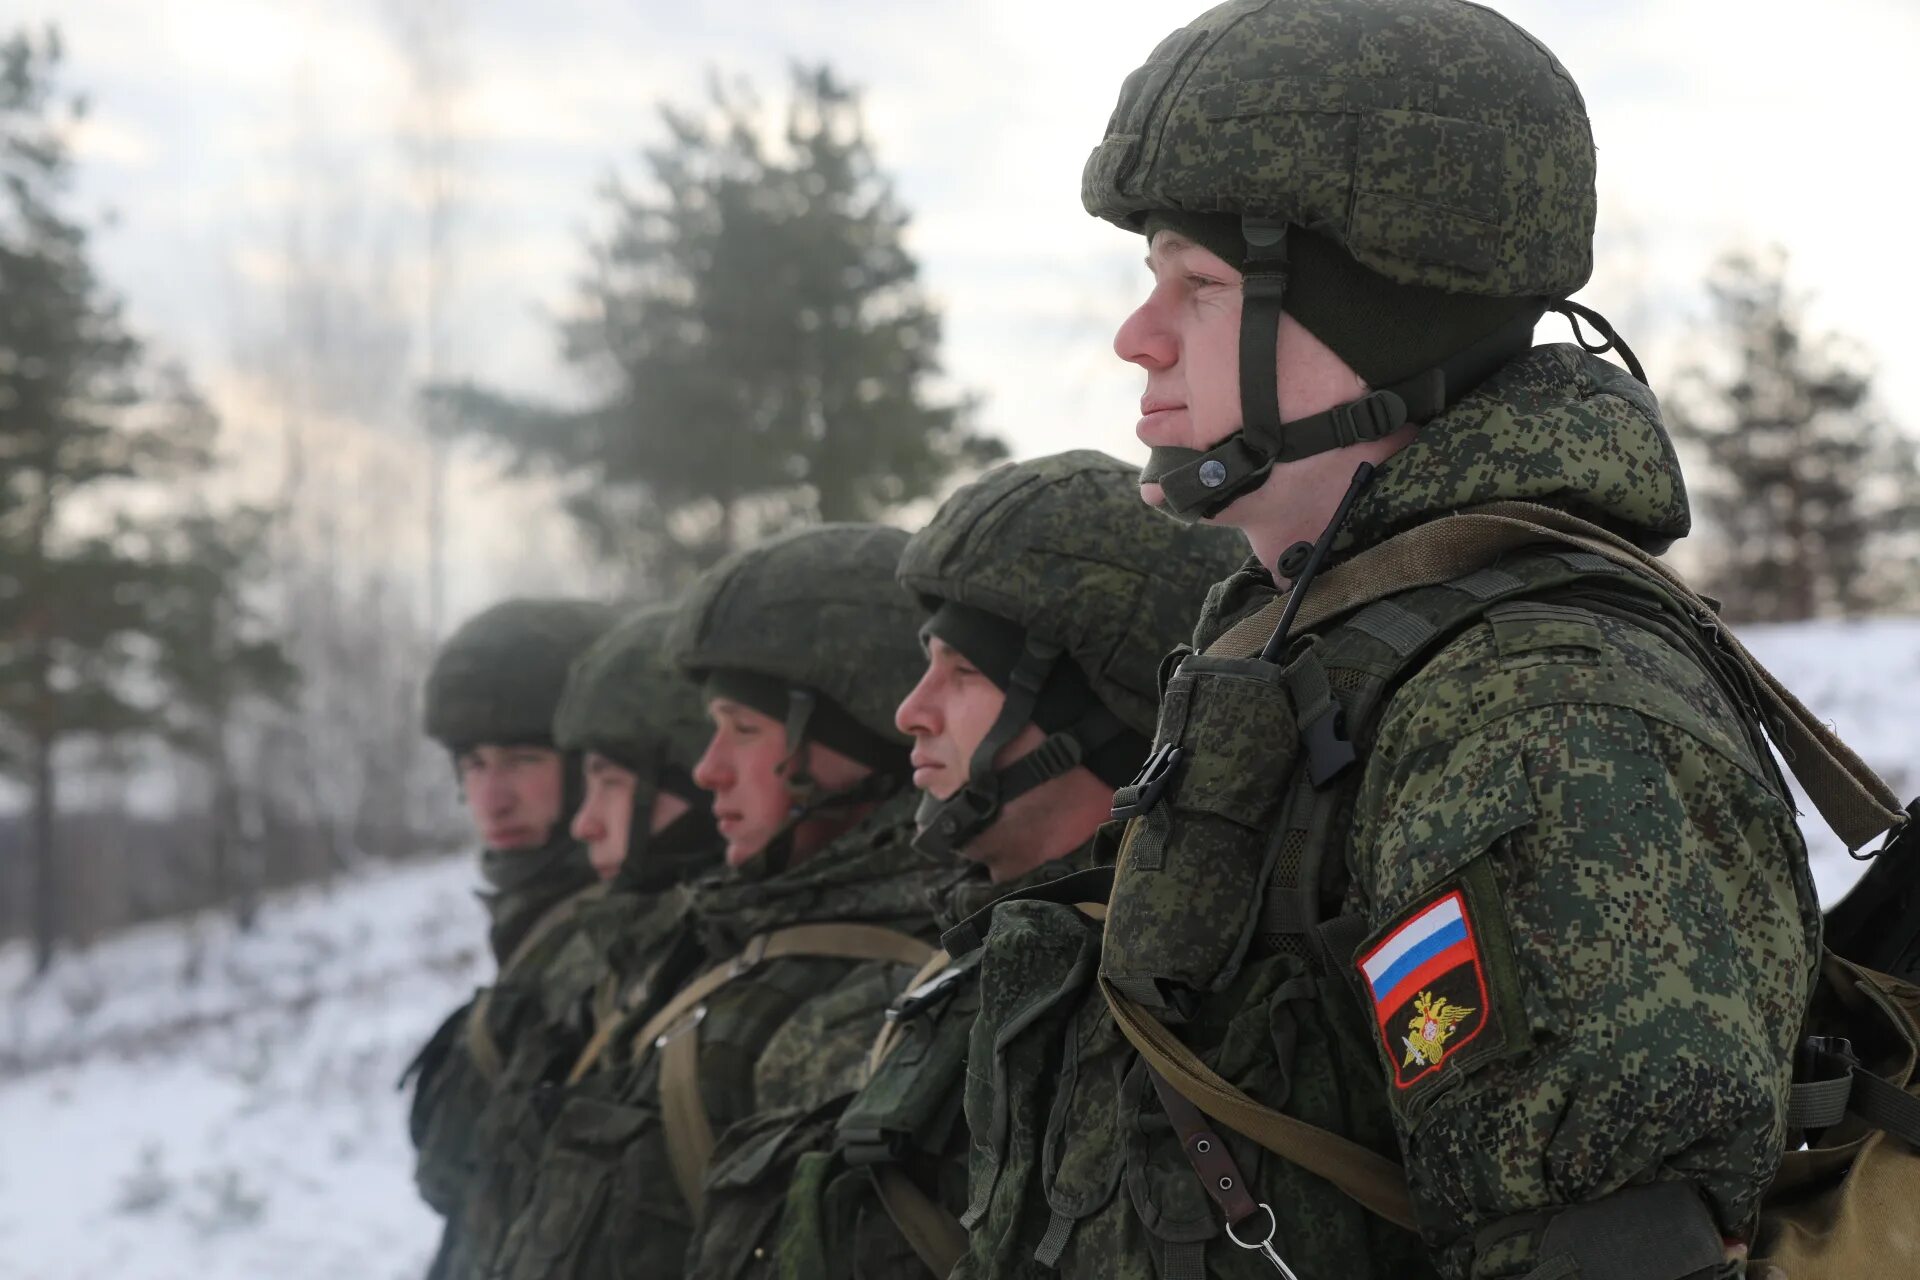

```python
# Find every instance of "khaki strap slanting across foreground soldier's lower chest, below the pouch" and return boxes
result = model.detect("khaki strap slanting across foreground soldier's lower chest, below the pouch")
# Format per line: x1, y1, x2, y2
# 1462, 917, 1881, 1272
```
1100, 977, 1419, 1232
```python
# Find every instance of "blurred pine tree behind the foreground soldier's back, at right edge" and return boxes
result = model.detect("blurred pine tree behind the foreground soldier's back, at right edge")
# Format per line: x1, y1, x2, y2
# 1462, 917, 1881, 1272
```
1667, 249, 1920, 622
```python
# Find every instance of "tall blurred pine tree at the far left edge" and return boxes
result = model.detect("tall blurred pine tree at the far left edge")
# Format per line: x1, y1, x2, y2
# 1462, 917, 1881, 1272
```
0, 33, 295, 969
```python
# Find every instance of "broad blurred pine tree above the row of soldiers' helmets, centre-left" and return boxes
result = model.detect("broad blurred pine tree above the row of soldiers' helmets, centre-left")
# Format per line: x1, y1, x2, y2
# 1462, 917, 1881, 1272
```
444, 67, 1004, 583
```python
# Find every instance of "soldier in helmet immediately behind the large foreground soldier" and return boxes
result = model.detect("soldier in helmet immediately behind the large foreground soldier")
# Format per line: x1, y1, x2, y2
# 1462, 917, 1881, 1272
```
689, 451, 1242, 1280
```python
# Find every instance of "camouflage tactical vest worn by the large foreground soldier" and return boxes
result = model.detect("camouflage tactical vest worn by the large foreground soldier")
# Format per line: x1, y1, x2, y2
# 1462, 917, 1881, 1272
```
960, 505, 1907, 1276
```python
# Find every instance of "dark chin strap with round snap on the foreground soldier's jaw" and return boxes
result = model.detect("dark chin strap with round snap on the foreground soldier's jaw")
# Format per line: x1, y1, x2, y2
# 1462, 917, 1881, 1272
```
1140, 217, 1540, 522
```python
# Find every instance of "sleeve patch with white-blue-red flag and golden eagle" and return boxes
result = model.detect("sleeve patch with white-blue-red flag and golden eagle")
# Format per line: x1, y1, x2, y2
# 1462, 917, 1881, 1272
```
1354, 858, 1524, 1092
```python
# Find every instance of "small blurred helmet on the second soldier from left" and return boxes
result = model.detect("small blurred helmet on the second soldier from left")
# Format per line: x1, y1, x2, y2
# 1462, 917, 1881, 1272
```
553, 604, 712, 775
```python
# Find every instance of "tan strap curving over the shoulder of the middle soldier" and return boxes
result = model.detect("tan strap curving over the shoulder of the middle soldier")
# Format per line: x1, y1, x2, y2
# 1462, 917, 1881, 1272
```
634, 923, 935, 1217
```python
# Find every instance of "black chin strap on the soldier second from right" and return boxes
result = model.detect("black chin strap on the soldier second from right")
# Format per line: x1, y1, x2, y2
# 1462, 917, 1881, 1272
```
914, 635, 1125, 860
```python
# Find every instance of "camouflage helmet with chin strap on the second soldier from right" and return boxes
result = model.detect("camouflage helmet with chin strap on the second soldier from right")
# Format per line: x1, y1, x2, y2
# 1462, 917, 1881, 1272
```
899, 449, 1246, 854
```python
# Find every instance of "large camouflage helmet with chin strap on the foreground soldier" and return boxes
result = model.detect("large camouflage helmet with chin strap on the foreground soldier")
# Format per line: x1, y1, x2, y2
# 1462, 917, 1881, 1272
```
1081, 0, 1605, 518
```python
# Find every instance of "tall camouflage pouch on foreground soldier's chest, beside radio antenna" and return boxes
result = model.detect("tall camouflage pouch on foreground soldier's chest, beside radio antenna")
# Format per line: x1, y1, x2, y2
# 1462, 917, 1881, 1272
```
1100, 652, 1311, 1021
